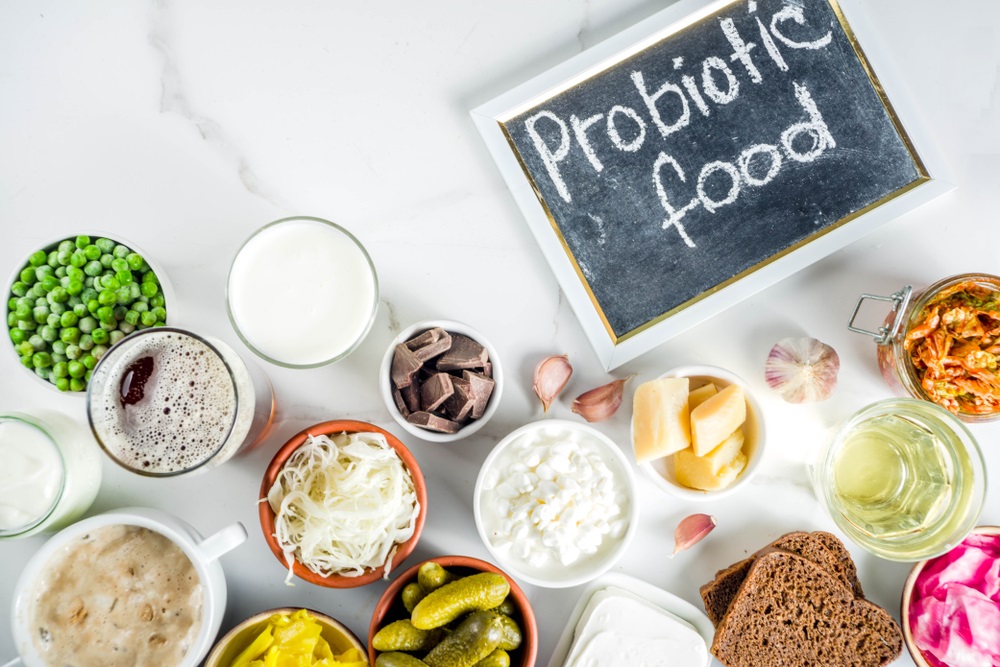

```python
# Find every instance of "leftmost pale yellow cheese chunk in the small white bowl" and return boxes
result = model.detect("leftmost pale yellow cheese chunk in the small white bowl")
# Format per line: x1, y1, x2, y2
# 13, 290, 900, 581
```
632, 378, 691, 463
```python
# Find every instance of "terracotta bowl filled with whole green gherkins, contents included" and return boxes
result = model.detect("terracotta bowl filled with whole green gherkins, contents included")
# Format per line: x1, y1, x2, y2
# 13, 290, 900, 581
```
368, 556, 538, 667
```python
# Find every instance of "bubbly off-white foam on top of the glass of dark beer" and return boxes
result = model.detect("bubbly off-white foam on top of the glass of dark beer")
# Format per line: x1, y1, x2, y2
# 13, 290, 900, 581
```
91, 332, 242, 474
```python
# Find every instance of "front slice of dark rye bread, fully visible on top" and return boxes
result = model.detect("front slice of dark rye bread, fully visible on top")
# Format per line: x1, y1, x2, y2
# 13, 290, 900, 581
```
712, 550, 903, 667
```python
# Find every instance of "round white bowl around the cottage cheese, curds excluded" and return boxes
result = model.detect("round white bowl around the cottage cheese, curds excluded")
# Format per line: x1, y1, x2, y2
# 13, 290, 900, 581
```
473, 419, 639, 588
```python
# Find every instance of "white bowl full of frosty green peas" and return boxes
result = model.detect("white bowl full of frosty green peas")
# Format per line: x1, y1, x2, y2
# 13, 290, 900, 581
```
6, 234, 173, 396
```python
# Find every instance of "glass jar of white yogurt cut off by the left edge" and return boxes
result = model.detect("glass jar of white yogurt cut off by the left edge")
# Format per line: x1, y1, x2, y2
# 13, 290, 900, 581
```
0, 411, 101, 541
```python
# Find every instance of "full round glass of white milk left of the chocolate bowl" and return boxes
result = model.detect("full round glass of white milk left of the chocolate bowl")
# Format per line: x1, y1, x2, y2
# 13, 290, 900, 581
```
226, 217, 379, 368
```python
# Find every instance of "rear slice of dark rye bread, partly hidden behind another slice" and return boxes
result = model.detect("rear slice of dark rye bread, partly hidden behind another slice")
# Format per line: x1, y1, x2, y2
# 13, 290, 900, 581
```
700, 531, 864, 625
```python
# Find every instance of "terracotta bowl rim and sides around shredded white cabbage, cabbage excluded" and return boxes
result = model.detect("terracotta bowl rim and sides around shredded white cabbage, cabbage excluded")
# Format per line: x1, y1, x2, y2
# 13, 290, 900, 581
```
258, 419, 427, 588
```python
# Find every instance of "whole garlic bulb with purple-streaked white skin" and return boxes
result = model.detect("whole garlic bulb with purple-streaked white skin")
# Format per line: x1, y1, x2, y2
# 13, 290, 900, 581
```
764, 338, 840, 403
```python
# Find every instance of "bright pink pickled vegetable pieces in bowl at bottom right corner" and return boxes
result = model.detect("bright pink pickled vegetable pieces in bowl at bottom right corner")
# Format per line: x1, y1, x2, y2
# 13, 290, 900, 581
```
909, 534, 1000, 667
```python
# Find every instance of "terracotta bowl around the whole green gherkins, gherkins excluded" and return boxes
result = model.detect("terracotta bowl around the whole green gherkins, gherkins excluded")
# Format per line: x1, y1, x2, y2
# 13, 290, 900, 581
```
368, 556, 538, 667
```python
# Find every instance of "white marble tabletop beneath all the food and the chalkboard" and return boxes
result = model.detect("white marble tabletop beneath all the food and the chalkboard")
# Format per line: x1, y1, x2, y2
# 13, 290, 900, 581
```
0, 0, 1000, 665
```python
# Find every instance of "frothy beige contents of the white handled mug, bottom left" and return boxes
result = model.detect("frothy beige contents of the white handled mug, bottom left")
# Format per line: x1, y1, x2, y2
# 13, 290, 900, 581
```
31, 526, 204, 667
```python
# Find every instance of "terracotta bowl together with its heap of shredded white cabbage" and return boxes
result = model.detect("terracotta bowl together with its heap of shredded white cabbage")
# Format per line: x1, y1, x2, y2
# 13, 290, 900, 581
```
258, 420, 427, 588
